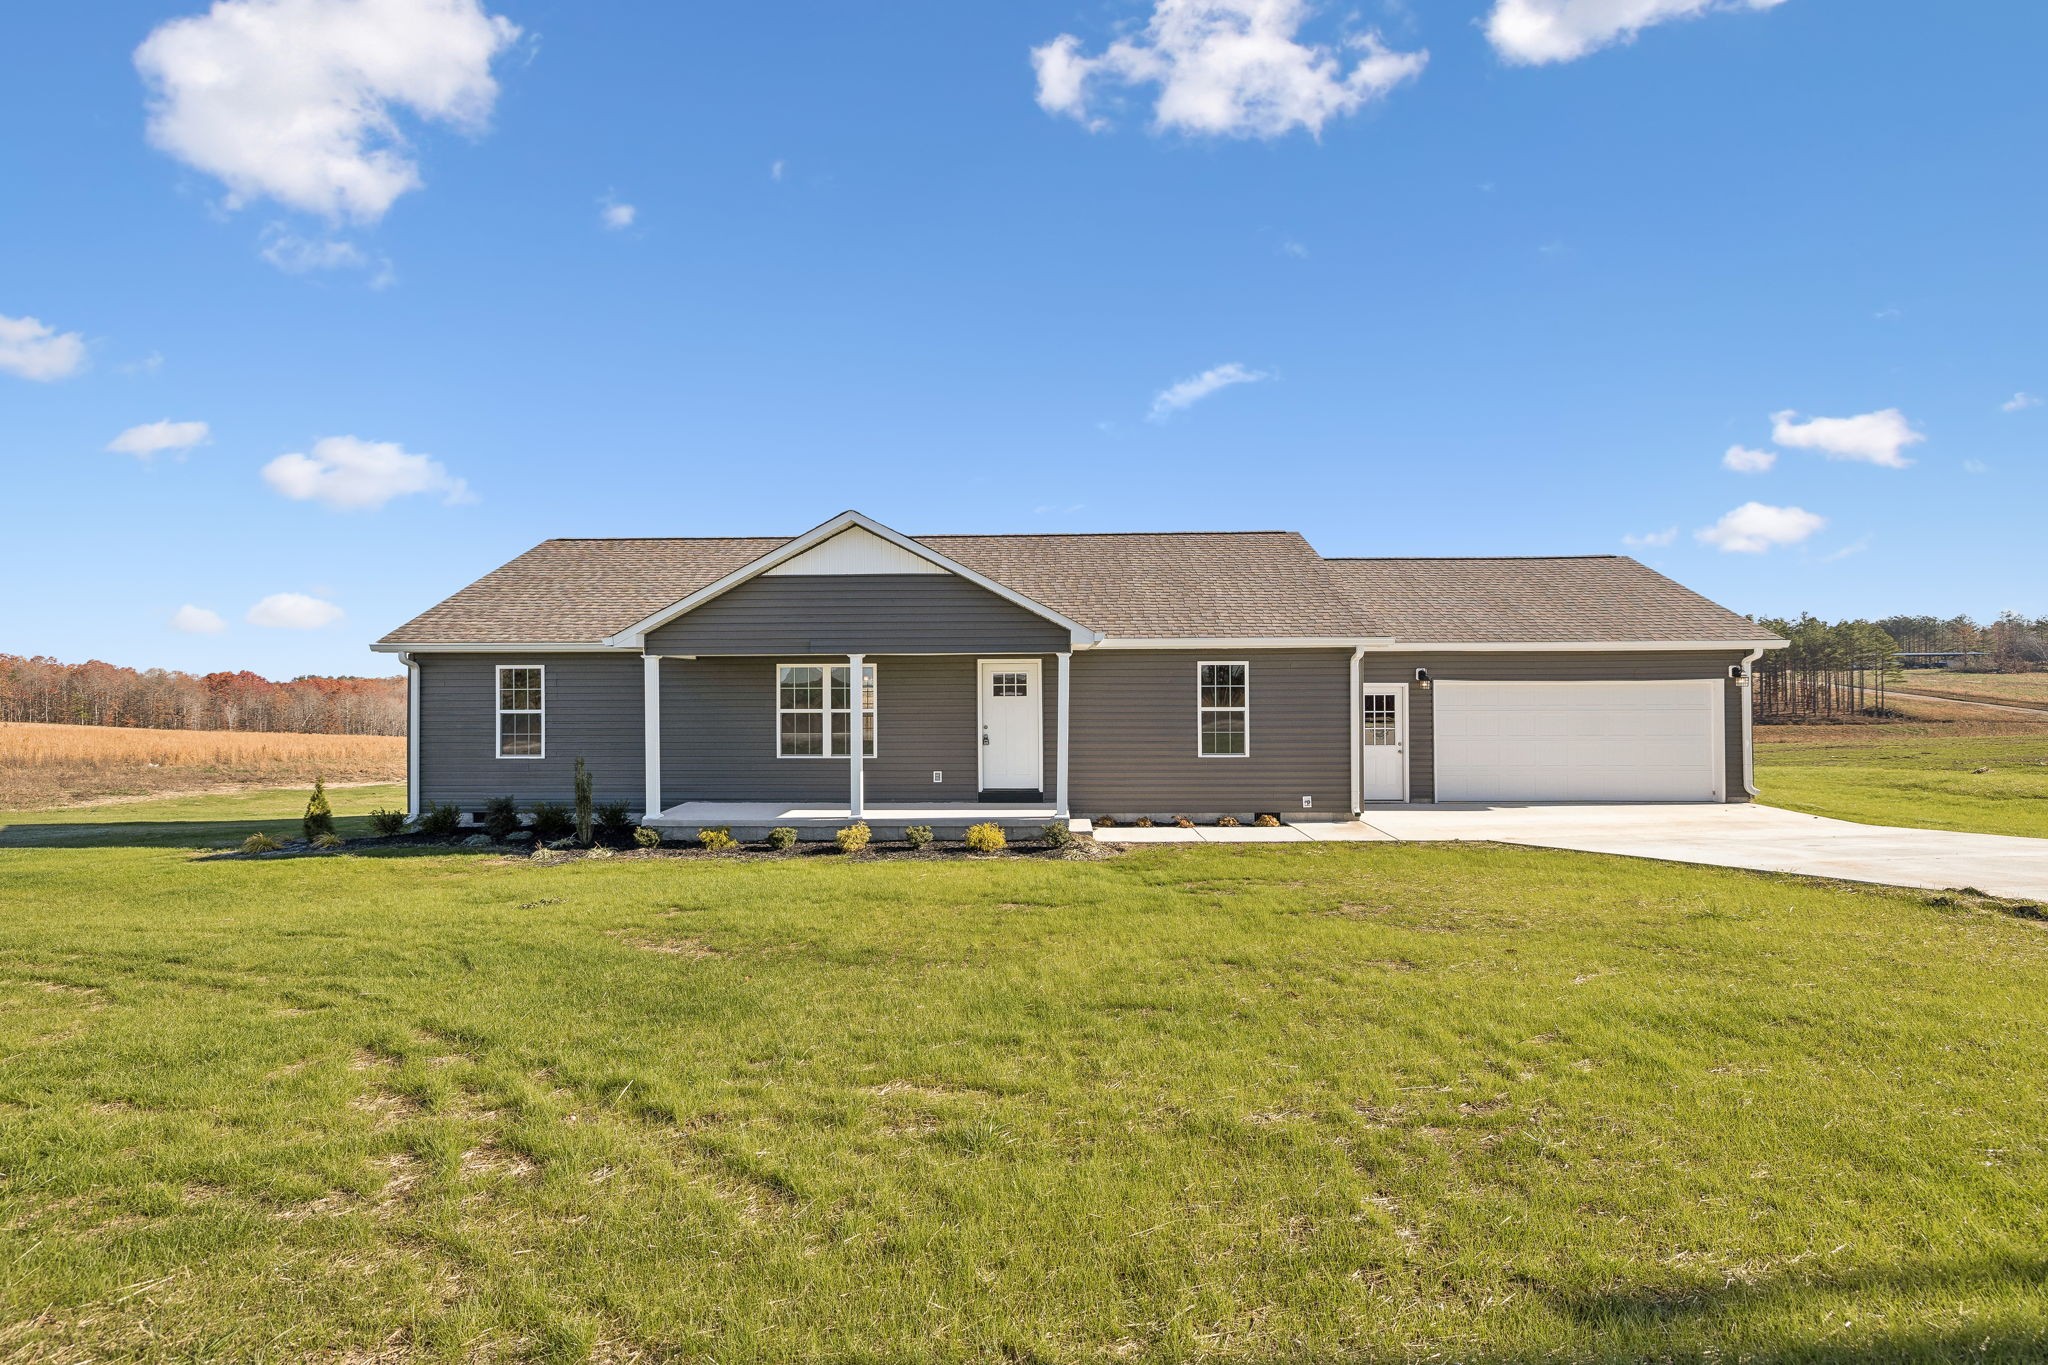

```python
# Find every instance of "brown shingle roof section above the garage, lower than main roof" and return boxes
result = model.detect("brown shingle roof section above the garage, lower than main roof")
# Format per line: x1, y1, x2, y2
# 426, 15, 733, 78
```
1327, 555, 1769, 645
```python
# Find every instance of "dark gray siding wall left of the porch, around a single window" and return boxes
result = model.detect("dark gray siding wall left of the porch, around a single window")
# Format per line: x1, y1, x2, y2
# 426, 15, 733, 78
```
416, 653, 645, 810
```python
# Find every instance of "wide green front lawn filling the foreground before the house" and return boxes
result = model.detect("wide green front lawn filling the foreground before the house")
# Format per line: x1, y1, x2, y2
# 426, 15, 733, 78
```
0, 785, 2048, 1363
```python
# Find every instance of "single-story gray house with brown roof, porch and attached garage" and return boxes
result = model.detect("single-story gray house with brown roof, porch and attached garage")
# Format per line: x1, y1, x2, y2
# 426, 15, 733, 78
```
375, 512, 1784, 831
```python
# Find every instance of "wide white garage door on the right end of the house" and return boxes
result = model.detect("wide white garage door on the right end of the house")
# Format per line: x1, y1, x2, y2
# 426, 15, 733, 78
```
1436, 681, 1726, 800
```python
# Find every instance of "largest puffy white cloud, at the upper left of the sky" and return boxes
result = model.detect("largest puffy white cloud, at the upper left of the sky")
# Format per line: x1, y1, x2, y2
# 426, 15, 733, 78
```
135, 0, 520, 223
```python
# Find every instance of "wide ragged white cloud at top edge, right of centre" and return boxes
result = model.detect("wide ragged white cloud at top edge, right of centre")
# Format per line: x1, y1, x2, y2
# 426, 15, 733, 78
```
1030, 0, 1430, 137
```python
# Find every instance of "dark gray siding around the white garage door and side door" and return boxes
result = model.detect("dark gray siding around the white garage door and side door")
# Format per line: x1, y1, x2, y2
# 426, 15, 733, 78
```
1362, 649, 1749, 800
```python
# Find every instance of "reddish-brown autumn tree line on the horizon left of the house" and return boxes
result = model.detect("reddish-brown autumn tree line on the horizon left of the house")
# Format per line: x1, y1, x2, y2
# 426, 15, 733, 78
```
0, 655, 406, 735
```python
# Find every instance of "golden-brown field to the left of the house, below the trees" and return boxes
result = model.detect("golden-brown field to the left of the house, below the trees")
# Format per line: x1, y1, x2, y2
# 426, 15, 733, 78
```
0, 722, 406, 810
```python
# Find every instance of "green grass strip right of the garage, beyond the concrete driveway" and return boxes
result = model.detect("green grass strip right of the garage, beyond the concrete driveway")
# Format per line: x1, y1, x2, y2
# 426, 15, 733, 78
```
1757, 722, 2048, 839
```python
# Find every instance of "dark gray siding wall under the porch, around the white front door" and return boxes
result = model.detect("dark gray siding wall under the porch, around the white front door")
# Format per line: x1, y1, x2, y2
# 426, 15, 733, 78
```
662, 653, 1059, 804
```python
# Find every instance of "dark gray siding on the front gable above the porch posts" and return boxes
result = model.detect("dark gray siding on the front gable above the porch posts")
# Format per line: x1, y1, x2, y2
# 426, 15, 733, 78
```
647, 573, 1069, 657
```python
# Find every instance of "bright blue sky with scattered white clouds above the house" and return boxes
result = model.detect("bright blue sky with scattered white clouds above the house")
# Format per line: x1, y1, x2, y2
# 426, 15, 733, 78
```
0, 0, 2048, 675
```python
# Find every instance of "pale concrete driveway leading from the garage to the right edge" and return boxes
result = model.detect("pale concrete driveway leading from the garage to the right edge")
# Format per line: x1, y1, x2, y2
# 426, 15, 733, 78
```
1364, 804, 2048, 900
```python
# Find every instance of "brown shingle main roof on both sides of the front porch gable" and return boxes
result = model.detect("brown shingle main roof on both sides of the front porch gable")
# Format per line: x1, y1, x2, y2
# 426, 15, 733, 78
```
381, 530, 1378, 645
